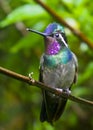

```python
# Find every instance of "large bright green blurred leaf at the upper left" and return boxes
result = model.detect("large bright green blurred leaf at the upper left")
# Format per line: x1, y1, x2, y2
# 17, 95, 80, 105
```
0, 5, 46, 27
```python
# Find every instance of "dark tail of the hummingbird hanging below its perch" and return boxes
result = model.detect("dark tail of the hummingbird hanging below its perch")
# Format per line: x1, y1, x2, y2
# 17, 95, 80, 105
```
40, 93, 67, 124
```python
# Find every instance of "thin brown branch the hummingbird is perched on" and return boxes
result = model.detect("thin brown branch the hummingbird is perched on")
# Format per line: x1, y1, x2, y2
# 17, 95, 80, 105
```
0, 67, 93, 107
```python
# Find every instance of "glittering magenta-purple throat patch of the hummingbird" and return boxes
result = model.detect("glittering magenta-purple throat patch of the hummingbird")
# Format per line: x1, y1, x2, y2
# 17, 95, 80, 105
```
47, 41, 61, 55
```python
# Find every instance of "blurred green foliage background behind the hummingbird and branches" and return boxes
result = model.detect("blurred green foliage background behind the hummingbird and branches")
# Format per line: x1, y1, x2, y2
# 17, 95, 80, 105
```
0, 0, 93, 130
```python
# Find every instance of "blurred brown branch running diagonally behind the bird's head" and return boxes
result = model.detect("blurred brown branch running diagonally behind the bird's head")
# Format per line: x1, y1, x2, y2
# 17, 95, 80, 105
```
34, 0, 93, 49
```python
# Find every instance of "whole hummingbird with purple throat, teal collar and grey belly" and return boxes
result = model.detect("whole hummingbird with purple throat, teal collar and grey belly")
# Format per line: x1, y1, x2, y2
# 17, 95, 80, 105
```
28, 22, 78, 124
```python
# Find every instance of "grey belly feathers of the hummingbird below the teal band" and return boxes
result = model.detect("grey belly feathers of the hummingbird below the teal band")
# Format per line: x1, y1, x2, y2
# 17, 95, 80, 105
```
43, 63, 75, 88
